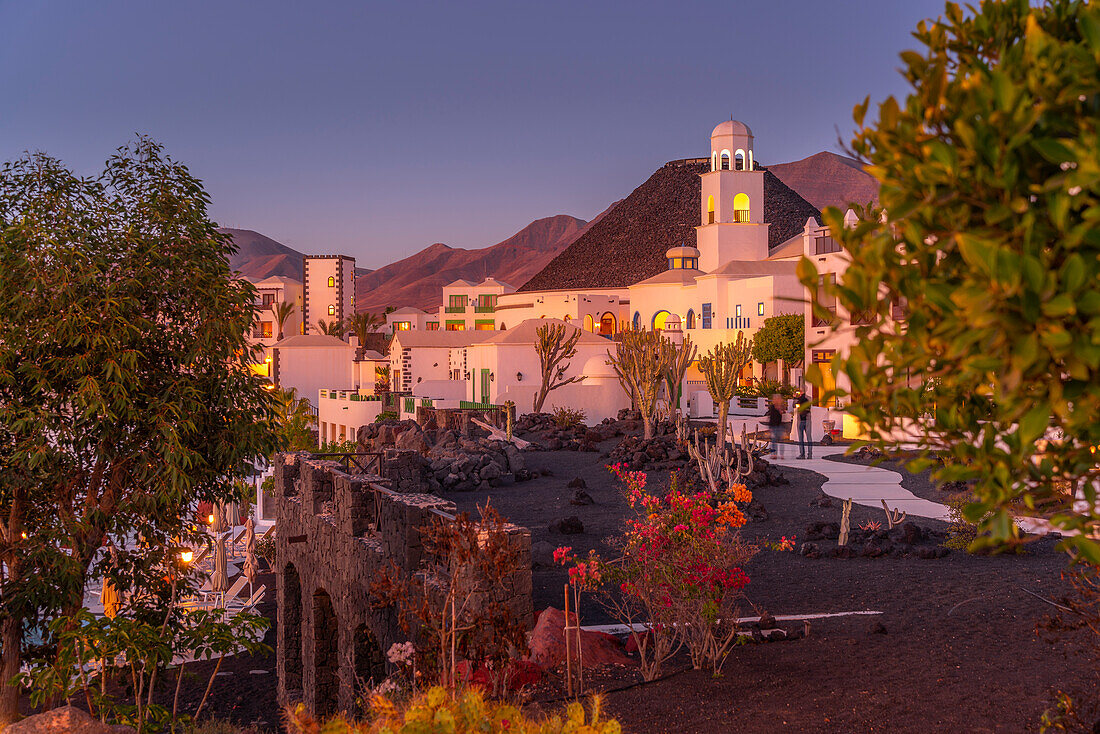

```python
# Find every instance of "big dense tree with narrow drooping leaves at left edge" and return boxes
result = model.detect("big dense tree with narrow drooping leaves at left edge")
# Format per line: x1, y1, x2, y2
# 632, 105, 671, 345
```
0, 139, 277, 724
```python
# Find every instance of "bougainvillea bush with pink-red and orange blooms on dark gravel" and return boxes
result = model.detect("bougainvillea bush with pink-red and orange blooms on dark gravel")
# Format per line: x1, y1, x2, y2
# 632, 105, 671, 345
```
558, 463, 757, 680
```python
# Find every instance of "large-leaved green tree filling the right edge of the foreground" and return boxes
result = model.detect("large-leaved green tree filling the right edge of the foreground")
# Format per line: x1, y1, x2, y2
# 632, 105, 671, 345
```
800, 0, 1100, 556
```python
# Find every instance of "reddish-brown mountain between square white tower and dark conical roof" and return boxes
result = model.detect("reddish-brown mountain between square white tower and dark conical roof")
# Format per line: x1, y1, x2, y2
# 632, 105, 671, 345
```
355, 213, 615, 313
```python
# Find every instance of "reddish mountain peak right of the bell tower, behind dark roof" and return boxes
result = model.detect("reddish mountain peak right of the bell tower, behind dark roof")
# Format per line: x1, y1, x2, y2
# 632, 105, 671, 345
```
768, 151, 879, 209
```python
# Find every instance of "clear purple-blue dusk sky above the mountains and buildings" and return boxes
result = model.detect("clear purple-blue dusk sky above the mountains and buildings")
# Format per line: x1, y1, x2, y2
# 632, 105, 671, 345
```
0, 0, 943, 267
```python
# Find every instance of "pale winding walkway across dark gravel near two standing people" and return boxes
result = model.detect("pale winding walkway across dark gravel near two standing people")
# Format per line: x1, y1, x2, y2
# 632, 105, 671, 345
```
765, 443, 948, 521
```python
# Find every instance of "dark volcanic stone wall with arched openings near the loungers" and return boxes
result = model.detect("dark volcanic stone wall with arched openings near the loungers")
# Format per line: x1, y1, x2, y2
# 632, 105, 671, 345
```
273, 453, 532, 715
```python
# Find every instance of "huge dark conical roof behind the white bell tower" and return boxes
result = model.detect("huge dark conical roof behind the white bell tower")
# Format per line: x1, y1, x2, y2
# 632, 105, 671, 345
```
519, 158, 821, 291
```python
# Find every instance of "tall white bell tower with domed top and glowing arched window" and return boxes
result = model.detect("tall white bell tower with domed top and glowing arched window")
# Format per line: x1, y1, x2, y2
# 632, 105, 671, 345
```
695, 120, 768, 273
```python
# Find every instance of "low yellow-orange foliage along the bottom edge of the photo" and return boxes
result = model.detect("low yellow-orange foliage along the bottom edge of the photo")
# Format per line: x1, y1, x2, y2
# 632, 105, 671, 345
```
285, 687, 623, 734
